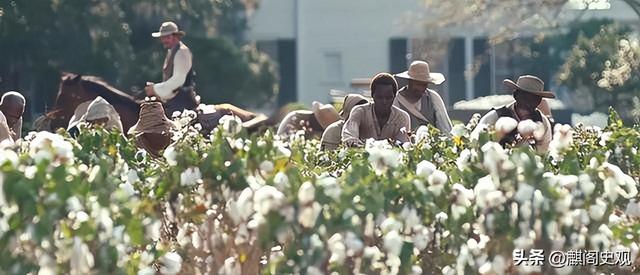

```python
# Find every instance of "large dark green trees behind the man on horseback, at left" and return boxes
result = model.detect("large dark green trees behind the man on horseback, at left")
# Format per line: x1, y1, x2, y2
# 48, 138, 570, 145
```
0, 0, 277, 122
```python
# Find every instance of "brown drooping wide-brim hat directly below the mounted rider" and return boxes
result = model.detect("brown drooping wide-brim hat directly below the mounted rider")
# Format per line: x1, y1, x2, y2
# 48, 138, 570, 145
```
128, 102, 176, 136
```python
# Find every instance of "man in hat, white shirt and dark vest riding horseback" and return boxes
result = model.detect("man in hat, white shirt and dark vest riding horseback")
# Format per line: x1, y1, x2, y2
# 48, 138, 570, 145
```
144, 22, 200, 115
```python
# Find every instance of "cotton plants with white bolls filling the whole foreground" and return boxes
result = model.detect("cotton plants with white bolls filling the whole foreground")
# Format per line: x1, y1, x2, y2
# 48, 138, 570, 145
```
0, 111, 640, 274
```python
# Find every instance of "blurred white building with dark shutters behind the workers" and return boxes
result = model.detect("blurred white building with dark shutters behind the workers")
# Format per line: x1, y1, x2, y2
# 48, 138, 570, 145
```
248, 0, 638, 108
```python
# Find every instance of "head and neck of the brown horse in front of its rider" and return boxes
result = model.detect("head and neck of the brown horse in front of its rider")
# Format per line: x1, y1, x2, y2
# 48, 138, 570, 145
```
36, 73, 141, 132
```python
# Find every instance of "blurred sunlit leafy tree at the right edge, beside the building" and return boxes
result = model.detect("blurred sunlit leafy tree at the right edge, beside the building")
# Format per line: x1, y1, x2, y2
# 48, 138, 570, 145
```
557, 24, 640, 121
